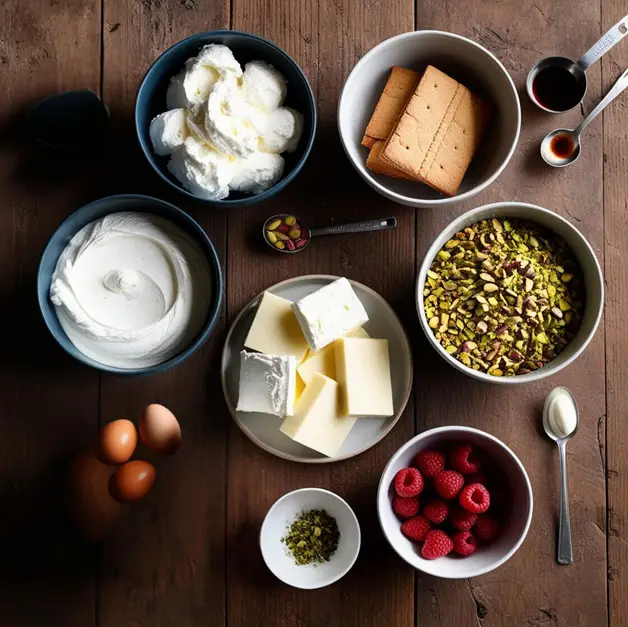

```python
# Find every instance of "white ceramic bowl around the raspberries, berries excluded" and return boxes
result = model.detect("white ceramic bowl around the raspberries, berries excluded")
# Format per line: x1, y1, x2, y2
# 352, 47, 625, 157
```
377, 427, 533, 579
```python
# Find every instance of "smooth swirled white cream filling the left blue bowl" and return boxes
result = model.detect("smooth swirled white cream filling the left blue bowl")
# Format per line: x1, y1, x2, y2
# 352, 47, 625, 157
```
50, 212, 214, 369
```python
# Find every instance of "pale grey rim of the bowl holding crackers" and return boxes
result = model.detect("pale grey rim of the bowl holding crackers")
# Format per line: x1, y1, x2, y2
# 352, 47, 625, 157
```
336, 29, 521, 207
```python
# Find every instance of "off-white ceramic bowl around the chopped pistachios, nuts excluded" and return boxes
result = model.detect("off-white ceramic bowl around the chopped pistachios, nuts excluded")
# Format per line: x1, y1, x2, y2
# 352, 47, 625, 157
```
416, 202, 604, 385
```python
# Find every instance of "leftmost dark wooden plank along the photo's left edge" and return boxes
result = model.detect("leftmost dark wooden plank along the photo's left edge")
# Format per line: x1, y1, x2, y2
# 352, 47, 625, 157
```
0, 0, 100, 627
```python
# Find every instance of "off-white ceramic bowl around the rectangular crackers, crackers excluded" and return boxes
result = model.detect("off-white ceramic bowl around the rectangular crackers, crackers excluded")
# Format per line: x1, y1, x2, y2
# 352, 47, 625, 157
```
338, 30, 521, 207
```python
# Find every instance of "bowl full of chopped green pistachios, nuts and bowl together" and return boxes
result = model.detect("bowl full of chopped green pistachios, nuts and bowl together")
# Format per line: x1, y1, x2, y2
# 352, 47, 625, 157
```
416, 202, 604, 384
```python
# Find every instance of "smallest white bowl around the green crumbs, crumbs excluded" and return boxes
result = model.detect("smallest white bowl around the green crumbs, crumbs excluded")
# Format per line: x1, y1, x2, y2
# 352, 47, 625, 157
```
260, 488, 361, 590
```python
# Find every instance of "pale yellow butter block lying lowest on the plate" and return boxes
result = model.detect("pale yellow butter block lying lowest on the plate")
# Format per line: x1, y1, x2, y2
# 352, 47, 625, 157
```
280, 373, 357, 457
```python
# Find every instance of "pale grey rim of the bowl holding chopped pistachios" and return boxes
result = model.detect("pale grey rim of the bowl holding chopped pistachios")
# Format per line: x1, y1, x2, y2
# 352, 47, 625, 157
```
415, 201, 604, 385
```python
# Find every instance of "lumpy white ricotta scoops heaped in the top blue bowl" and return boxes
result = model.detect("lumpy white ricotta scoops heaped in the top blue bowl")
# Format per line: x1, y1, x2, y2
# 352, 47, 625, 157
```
149, 44, 303, 200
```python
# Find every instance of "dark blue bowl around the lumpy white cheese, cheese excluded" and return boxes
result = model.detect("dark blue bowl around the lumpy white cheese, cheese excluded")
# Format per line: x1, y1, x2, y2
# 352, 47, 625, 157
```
135, 30, 316, 207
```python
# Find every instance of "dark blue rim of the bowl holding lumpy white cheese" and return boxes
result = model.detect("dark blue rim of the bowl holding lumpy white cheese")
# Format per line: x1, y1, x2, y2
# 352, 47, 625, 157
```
134, 29, 318, 207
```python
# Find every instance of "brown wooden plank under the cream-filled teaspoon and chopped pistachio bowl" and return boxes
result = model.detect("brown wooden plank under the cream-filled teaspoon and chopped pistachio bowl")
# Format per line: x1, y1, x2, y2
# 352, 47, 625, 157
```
416, 0, 607, 627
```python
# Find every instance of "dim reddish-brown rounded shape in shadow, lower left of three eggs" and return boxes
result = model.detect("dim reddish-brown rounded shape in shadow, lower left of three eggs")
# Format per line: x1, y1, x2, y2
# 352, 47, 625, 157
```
67, 449, 124, 542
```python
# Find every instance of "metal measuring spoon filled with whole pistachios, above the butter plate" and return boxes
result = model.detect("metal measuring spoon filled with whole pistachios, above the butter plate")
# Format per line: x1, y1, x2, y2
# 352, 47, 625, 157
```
262, 213, 397, 254
